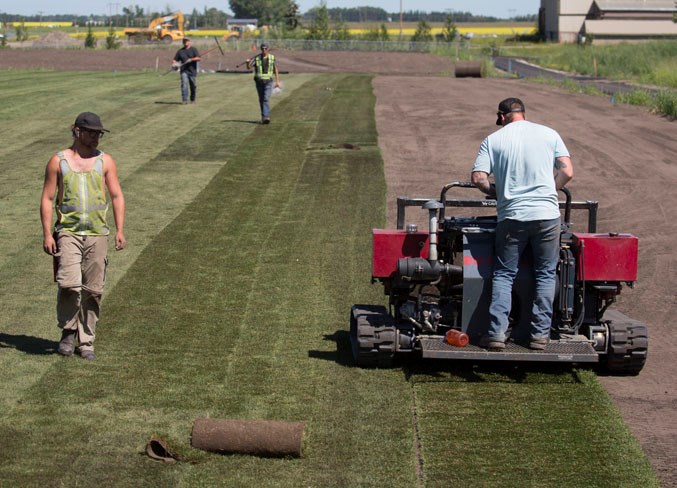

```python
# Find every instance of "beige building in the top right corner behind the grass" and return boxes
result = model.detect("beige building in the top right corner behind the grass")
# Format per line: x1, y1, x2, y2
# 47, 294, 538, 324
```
539, 0, 677, 42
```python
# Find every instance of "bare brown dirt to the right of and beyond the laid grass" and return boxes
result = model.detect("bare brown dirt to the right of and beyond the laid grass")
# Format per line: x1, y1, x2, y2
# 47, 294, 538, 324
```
0, 46, 677, 487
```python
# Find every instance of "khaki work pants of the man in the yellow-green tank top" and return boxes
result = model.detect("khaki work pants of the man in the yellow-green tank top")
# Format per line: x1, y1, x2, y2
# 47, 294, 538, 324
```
56, 232, 108, 353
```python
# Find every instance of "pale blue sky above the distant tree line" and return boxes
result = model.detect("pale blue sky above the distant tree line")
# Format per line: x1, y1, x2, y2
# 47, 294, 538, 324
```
0, 0, 541, 18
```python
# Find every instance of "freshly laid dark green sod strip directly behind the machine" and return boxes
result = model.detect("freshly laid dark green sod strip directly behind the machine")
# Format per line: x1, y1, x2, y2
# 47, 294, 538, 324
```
410, 364, 659, 488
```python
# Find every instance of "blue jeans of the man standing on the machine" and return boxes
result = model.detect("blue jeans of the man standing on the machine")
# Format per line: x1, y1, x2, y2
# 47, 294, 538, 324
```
488, 218, 560, 341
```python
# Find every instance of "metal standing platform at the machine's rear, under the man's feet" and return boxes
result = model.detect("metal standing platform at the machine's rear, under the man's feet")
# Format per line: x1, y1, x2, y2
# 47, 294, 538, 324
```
420, 336, 599, 363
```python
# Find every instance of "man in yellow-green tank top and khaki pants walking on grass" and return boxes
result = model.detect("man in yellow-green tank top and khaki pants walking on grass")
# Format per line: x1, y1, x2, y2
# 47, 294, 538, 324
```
40, 112, 126, 359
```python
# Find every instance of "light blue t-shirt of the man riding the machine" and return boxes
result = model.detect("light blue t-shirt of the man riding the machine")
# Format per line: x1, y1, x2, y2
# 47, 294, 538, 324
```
472, 120, 569, 222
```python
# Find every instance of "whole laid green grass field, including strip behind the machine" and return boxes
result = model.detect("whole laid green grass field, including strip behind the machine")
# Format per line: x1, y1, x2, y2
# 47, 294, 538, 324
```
0, 71, 658, 488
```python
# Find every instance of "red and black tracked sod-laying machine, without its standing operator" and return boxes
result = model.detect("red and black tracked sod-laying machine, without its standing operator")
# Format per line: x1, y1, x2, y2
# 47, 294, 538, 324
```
350, 182, 648, 375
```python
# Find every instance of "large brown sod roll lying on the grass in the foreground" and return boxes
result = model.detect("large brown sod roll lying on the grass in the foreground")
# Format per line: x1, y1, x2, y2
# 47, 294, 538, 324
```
191, 419, 305, 457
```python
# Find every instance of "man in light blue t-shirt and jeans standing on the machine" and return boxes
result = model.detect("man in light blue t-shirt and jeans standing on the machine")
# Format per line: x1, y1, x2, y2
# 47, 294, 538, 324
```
471, 98, 574, 350
